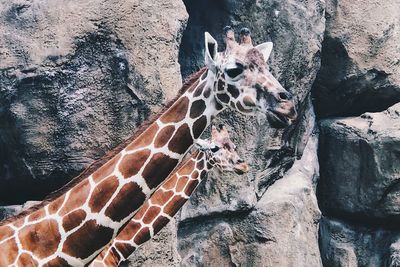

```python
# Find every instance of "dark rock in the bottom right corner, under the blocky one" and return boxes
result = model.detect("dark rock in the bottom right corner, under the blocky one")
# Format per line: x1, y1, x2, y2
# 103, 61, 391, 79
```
320, 217, 400, 267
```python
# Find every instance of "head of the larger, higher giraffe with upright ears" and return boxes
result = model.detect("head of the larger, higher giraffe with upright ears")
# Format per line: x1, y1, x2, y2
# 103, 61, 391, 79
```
205, 26, 297, 128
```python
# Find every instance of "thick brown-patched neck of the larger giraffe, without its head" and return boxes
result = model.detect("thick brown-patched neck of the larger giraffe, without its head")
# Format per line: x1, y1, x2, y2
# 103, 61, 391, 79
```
0, 69, 223, 266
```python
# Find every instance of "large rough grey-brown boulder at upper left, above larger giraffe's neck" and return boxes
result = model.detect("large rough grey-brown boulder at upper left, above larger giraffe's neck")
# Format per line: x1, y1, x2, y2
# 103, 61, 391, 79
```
0, 0, 187, 203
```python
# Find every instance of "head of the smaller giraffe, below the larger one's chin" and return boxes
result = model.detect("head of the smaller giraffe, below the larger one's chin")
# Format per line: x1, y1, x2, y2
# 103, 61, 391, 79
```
198, 125, 249, 174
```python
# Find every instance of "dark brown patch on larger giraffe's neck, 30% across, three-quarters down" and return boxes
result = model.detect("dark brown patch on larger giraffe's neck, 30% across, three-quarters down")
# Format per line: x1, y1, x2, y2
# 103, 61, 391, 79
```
105, 182, 146, 222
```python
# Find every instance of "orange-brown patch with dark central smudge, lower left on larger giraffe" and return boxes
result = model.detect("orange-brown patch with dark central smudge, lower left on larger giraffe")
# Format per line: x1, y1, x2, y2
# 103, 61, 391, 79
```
19, 219, 61, 259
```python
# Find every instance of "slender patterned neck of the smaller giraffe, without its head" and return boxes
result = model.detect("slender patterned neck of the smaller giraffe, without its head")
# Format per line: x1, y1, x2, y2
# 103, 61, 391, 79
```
90, 151, 215, 267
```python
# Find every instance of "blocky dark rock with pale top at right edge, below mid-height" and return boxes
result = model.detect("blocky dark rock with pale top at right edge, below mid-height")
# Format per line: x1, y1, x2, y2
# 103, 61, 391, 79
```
318, 103, 400, 225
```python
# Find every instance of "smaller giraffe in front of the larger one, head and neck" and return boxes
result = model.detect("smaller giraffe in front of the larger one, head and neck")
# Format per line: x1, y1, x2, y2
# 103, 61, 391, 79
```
89, 125, 249, 267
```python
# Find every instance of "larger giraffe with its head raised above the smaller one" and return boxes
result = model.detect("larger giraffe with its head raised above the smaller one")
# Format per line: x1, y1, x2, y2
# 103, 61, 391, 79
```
0, 26, 296, 266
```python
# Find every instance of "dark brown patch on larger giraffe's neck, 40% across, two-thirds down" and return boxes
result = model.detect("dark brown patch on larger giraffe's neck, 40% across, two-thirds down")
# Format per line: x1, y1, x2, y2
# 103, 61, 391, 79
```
143, 153, 178, 189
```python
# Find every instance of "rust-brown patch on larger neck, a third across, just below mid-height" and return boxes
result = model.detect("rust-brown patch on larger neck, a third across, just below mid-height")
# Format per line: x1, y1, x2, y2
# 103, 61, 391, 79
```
118, 149, 151, 178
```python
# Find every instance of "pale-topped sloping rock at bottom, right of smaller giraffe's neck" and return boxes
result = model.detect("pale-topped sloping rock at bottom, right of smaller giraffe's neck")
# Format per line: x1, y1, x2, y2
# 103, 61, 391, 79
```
178, 127, 322, 266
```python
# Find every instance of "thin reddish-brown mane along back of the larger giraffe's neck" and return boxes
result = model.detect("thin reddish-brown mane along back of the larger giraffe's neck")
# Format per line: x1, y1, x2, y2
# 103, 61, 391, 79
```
0, 67, 207, 226
